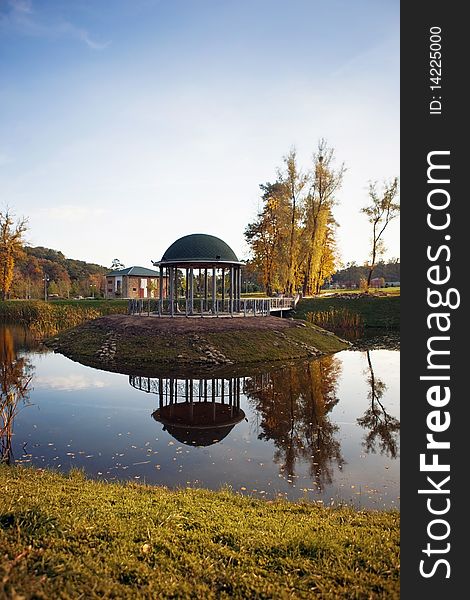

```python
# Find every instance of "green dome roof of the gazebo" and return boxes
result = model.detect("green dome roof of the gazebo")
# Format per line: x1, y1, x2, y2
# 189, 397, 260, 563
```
161, 233, 239, 263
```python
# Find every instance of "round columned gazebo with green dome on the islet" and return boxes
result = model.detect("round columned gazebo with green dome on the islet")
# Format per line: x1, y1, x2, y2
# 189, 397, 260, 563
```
152, 233, 242, 316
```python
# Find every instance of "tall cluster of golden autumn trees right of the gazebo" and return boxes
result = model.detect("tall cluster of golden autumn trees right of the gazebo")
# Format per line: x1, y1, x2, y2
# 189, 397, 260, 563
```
245, 144, 345, 295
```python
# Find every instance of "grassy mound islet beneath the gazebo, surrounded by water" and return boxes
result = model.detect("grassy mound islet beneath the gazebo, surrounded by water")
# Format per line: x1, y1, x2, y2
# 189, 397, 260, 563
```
46, 317, 348, 374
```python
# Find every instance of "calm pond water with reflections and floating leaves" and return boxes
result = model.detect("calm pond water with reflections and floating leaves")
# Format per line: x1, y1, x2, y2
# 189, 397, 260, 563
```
0, 327, 400, 508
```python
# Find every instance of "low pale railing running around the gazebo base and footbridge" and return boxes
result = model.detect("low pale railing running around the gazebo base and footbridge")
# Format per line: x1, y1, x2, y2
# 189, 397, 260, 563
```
127, 297, 295, 317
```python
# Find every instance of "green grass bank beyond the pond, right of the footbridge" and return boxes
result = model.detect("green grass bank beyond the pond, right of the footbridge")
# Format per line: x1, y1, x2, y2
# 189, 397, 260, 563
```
295, 295, 400, 329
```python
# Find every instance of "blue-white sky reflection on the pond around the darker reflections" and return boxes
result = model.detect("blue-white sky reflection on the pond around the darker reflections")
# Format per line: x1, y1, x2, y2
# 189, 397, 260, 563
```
14, 351, 399, 508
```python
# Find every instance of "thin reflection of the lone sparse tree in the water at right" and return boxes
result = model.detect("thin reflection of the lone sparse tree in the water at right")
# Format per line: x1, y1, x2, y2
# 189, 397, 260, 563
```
357, 350, 400, 458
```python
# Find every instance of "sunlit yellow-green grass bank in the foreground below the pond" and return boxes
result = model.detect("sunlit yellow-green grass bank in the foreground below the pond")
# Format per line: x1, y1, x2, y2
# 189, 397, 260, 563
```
0, 466, 399, 600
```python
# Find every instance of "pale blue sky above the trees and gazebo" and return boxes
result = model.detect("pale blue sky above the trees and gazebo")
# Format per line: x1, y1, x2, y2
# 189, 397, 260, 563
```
0, 0, 400, 267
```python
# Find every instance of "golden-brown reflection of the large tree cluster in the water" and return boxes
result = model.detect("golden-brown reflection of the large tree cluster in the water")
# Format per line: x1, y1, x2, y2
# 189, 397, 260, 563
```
244, 356, 344, 485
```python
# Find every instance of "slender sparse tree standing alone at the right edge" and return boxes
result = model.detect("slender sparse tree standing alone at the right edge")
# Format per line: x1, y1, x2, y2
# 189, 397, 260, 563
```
361, 177, 400, 287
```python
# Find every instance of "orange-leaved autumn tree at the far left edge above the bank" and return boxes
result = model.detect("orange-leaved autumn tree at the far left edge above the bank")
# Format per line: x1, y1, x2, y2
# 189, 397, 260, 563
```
0, 208, 28, 300
